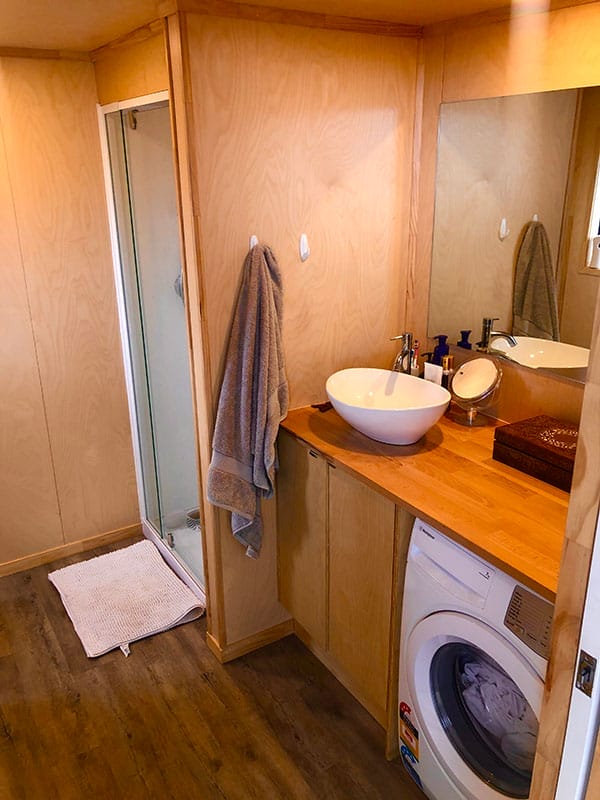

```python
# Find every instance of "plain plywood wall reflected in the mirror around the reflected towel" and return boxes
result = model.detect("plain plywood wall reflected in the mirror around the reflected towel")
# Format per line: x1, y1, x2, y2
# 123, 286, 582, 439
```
429, 90, 576, 343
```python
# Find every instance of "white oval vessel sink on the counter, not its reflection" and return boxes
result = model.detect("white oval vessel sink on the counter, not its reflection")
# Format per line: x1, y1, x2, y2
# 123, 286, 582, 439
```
325, 368, 450, 444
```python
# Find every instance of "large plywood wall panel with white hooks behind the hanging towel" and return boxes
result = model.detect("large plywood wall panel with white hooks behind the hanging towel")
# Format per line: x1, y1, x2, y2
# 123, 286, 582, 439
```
188, 15, 417, 406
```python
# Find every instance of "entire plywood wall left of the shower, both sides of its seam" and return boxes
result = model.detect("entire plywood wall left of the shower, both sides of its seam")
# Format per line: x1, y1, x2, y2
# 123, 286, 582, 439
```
0, 58, 139, 561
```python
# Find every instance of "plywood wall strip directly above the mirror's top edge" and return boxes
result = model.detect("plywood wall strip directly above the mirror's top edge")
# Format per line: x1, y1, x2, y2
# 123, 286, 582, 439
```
443, 2, 600, 102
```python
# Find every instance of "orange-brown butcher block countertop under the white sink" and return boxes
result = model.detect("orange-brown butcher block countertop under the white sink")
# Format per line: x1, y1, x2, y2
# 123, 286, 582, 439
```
281, 407, 569, 600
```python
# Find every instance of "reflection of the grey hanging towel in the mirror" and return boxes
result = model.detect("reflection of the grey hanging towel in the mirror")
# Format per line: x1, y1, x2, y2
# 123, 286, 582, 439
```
512, 222, 560, 342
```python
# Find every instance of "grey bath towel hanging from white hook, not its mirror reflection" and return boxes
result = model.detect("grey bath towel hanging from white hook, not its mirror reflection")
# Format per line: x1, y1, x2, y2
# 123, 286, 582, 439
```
208, 244, 288, 558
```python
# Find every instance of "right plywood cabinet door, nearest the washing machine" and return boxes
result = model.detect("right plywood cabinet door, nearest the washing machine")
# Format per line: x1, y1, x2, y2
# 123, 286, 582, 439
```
329, 468, 395, 726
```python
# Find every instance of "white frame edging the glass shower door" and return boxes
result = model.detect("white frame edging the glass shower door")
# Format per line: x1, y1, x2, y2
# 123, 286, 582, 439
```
96, 90, 206, 605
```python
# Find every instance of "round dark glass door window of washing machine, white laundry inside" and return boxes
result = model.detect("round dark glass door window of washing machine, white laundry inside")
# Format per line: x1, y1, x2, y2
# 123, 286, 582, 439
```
429, 641, 538, 798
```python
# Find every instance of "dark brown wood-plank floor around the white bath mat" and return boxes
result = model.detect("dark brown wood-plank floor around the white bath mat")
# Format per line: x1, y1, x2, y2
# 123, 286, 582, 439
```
0, 542, 424, 800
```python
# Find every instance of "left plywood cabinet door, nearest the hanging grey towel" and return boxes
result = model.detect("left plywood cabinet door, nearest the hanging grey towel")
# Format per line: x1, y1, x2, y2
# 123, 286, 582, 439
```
277, 431, 327, 649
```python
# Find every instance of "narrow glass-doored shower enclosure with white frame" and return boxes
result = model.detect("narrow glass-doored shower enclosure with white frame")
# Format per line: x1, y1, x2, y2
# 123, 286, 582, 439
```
100, 93, 204, 594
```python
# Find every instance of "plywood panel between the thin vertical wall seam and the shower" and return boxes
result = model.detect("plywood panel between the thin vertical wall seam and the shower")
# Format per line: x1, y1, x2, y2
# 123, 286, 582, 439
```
0, 59, 139, 542
